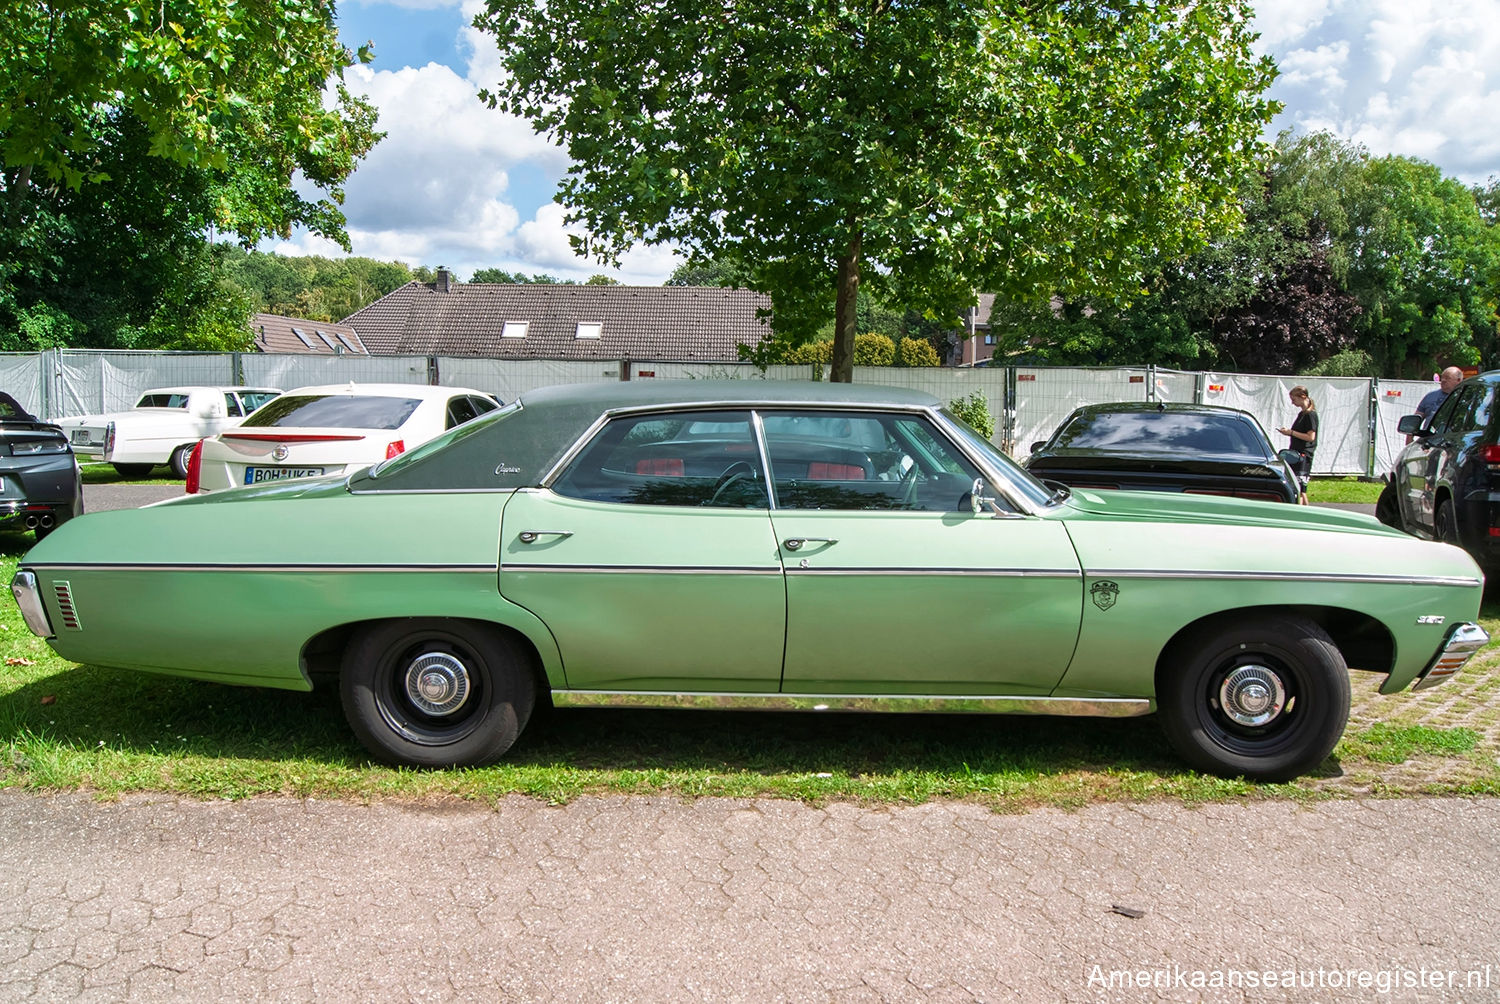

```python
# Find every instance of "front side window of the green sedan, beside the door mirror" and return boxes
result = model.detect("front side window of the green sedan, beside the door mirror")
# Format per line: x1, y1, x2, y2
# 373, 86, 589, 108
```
764, 411, 980, 512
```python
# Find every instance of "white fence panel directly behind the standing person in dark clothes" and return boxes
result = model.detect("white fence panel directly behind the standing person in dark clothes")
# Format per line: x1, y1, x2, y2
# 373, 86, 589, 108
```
1203, 374, 1371, 474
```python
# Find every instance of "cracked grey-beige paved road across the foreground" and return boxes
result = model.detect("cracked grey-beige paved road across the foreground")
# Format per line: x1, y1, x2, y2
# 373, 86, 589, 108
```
0, 791, 1500, 1001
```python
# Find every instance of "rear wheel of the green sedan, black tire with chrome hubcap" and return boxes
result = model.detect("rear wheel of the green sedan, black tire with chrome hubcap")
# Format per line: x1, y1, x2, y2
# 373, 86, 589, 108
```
339, 618, 536, 767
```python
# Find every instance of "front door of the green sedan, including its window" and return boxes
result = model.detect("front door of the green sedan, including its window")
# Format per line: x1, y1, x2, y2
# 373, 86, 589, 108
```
762, 411, 1083, 696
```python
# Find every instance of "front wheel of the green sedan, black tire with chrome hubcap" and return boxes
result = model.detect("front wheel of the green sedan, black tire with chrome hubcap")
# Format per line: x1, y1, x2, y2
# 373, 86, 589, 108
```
1157, 617, 1349, 780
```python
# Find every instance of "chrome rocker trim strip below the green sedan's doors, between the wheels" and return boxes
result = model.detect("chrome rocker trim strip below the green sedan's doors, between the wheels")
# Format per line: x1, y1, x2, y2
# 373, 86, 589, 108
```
552, 690, 1154, 717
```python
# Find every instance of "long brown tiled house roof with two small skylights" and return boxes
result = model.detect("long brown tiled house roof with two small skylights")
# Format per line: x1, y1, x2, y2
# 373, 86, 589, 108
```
344, 270, 771, 362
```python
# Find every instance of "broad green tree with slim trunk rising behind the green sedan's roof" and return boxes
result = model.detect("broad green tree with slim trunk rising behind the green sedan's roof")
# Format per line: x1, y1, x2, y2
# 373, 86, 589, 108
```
476, 0, 1275, 380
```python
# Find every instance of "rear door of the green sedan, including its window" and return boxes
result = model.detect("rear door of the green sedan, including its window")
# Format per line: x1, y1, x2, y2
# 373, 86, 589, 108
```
500, 411, 786, 693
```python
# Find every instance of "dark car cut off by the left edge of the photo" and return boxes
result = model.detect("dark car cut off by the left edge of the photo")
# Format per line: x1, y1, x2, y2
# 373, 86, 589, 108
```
0, 393, 84, 540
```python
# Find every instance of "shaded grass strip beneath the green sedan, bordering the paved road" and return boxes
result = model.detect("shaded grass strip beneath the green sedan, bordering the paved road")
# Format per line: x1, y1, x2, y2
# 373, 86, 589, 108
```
0, 534, 1500, 810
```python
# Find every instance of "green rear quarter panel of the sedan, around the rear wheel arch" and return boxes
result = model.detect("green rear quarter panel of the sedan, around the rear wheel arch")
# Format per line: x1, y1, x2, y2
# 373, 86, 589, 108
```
21, 491, 561, 689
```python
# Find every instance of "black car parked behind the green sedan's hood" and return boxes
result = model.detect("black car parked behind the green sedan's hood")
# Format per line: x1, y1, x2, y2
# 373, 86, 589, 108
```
1026, 402, 1299, 503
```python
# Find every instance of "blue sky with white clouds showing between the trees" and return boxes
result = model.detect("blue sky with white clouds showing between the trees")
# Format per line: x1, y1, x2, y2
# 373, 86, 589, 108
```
263, 0, 1500, 285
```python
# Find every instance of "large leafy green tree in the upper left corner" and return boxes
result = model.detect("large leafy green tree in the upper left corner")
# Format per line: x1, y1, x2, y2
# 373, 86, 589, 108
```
0, 0, 378, 348
